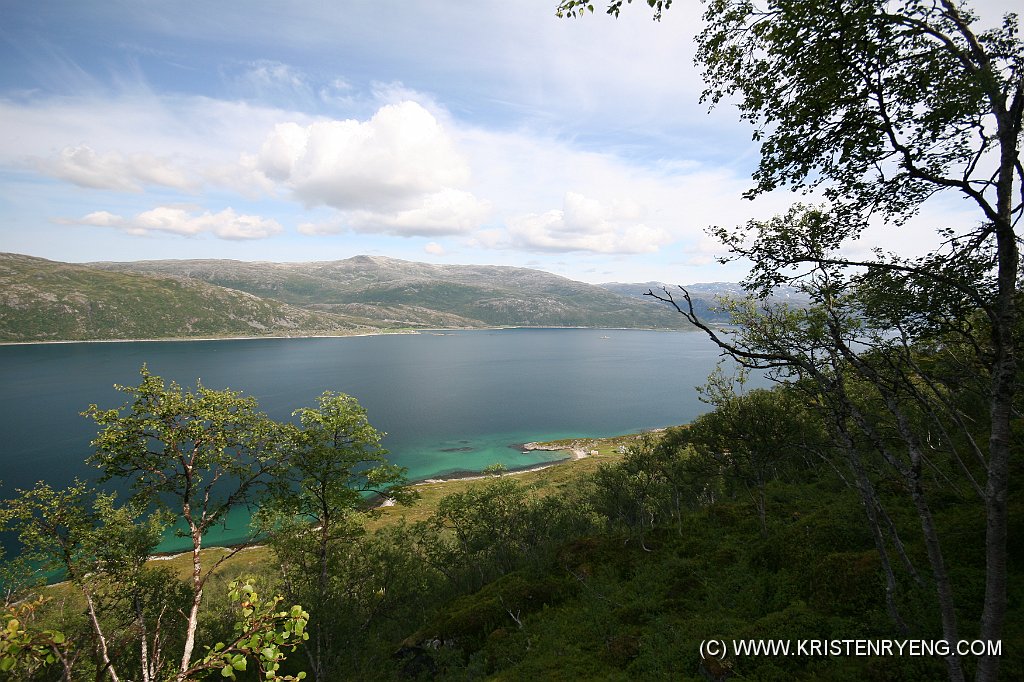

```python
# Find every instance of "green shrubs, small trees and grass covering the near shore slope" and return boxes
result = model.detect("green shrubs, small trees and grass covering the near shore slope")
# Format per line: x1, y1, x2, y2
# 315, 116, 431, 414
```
0, 366, 1024, 680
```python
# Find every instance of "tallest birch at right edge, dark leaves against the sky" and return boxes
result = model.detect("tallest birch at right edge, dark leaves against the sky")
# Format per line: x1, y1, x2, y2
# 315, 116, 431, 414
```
557, 0, 1024, 680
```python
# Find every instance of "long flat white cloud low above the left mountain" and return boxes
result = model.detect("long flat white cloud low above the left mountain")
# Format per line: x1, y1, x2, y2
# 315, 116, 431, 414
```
61, 206, 283, 240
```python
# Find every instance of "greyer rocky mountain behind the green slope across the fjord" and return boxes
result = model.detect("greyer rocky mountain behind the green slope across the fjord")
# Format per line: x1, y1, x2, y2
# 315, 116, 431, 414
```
88, 256, 686, 329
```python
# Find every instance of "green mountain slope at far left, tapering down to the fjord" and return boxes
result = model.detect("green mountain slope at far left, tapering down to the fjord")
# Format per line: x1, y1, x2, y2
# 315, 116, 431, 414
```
0, 253, 380, 341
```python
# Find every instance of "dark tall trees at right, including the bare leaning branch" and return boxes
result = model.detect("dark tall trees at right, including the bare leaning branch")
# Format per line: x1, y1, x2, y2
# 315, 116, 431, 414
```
557, 0, 1024, 682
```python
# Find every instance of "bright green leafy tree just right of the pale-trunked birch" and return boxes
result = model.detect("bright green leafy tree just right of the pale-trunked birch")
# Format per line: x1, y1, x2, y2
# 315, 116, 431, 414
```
259, 392, 415, 679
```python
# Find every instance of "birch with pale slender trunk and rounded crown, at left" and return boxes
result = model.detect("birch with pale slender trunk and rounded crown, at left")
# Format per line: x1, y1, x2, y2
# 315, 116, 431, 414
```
83, 367, 282, 680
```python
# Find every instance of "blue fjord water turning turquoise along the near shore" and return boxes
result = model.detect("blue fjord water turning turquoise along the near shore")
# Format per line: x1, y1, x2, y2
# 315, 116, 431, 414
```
0, 329, 753, 550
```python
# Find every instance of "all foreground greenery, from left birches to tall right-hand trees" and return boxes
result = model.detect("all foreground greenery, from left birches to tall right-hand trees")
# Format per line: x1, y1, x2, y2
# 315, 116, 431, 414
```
0, 0, 1024, 682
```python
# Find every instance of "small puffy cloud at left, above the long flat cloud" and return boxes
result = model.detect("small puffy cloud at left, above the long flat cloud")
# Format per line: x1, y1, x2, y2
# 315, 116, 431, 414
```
38, 144, 196, 191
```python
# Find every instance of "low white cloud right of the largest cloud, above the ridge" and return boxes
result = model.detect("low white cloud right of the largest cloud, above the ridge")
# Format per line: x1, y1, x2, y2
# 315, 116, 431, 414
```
508, 191, 673, 254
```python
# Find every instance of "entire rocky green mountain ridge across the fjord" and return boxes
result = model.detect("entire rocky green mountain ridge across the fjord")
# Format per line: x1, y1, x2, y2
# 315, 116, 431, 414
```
0, 254, 708, 342
